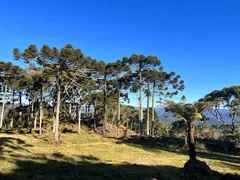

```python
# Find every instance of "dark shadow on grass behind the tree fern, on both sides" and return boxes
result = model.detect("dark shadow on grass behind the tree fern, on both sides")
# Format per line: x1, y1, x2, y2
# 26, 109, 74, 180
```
117, 137, 240, 164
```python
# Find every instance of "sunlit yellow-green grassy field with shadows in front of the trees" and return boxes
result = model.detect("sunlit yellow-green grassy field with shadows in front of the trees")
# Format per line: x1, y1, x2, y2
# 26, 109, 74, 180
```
0, 126, 240, 180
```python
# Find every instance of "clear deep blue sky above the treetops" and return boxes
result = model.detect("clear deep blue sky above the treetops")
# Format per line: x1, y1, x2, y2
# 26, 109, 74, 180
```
0, 0, 240, 106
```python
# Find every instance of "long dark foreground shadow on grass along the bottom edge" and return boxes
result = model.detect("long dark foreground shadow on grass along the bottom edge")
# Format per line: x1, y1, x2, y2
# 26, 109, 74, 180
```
0, 154, 236, 180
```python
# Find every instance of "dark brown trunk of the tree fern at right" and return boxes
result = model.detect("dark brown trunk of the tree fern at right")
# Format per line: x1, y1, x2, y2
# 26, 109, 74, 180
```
187, 121, 197, 161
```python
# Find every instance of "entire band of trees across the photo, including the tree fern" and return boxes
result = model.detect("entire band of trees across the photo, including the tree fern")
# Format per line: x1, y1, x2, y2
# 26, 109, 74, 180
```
0, 44, 240, 173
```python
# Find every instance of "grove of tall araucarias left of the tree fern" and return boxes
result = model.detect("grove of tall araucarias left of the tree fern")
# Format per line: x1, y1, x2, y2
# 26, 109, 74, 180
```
0, 44, 184, 143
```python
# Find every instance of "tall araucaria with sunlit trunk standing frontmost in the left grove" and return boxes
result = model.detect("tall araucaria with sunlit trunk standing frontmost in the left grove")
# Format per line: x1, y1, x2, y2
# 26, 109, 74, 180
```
13, 44, 93, 143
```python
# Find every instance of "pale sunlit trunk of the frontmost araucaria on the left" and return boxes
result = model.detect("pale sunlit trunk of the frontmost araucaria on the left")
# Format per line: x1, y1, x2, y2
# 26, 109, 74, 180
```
54, 84, 61, 143
